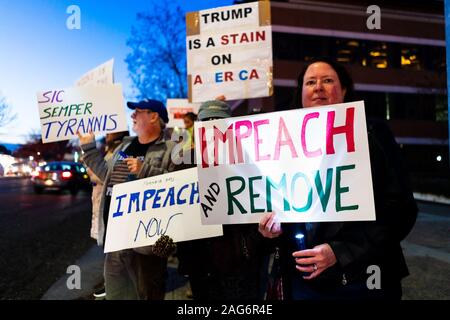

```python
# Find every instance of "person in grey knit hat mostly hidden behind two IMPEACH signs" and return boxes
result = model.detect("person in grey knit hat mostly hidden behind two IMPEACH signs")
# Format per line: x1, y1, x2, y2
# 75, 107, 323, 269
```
177, 96, 266, 301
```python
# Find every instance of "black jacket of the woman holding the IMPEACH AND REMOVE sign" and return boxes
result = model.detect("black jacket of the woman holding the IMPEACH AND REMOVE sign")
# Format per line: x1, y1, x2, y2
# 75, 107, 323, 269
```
282, 120, 418, 289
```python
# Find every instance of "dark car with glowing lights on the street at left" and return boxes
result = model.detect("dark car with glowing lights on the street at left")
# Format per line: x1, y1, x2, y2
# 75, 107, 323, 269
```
31, 161, 91, 195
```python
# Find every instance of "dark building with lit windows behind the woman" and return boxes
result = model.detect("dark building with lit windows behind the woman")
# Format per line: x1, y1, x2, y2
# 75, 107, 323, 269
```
234, 0, 449, 189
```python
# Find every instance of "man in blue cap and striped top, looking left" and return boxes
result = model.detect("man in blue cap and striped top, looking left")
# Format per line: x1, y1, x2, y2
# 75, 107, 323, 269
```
78, 99, 175, 300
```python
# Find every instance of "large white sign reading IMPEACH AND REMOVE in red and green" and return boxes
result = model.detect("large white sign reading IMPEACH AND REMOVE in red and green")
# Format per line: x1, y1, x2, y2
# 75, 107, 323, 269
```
195, 101, 375, 224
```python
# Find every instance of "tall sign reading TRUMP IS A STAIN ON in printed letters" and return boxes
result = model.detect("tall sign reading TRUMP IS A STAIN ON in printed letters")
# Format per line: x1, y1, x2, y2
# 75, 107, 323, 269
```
186, 1, 273, 102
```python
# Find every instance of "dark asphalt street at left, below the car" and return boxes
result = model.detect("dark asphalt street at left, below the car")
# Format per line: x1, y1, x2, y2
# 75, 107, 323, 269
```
0, 178, 94, 299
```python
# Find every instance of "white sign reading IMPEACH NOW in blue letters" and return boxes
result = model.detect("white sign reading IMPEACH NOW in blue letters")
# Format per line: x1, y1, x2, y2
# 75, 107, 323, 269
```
105, 168, 223, 252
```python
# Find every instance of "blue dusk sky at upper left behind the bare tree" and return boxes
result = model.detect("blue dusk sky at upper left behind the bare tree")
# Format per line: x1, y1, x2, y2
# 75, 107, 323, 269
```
0, 0, 233, 143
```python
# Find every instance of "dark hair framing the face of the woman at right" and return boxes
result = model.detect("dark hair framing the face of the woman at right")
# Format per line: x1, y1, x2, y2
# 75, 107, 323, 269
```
292, 57, 355, 109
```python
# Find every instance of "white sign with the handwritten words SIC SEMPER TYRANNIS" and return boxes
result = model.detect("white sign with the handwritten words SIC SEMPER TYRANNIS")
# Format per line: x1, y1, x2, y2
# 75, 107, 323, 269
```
37, 84, 128, 143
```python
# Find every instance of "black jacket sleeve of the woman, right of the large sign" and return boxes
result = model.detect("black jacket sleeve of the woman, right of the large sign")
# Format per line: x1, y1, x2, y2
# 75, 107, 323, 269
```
329, 121, 418, 268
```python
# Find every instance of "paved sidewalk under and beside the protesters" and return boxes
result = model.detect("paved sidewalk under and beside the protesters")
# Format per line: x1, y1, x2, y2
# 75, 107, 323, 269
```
42, 195, 450, 300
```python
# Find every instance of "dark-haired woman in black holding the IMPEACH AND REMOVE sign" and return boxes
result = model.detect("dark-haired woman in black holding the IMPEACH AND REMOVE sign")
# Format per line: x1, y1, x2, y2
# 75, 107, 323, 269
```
259, 59, 417, 300
